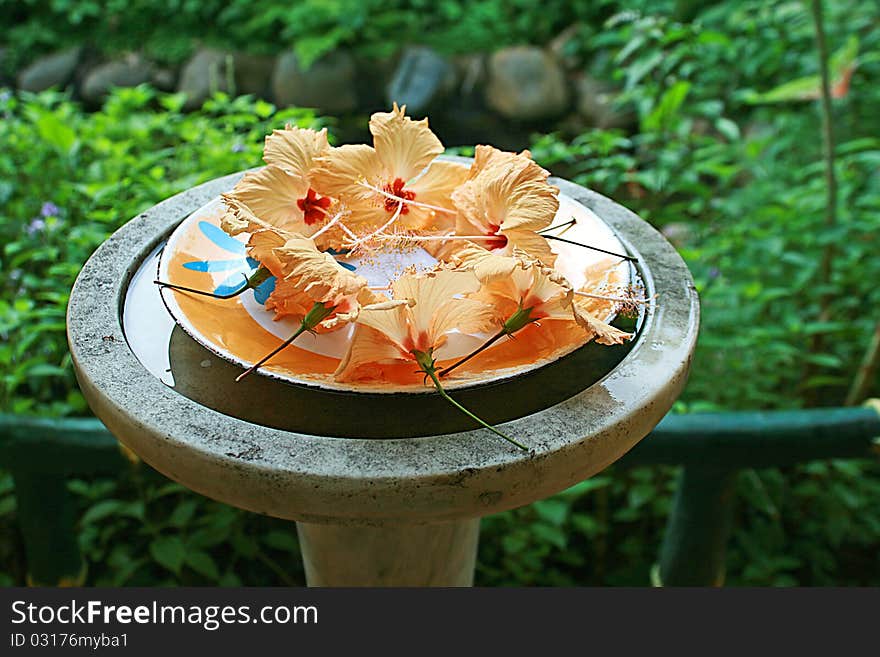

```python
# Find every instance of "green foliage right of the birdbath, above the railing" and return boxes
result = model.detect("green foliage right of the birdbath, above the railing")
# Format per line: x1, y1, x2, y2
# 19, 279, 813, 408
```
533, 3, 880, 410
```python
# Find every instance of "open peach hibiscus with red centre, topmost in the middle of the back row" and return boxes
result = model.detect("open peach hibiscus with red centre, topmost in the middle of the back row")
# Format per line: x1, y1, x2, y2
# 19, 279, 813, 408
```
314, 103, 467, 237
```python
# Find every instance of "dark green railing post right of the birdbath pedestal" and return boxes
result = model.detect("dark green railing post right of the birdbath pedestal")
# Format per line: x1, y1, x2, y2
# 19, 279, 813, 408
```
658, 465, 737, 586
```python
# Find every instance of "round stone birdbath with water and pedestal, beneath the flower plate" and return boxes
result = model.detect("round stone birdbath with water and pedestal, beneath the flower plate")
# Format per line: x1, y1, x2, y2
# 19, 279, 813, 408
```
68, 165, 699, 586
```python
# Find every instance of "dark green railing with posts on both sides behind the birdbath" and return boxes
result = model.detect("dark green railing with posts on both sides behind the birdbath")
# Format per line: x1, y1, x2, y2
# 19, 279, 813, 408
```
0, 400, 880, 586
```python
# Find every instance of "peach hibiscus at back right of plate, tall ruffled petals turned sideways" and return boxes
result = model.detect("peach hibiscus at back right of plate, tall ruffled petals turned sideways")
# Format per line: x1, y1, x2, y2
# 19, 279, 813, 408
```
452, 146, 559, 266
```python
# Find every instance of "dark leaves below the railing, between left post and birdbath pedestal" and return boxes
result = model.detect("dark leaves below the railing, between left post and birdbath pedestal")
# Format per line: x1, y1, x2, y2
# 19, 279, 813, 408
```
70, 468, 303, 586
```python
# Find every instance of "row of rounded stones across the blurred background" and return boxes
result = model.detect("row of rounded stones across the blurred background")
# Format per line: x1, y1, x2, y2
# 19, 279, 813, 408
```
0, 41, 632, 148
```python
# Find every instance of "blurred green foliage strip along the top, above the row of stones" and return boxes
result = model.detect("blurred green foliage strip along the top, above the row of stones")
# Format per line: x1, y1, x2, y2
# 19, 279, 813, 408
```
0, 0, 656, 71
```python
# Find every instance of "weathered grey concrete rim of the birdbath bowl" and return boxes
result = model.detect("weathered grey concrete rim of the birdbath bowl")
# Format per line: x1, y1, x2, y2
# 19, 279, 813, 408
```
68, 159, 699, 527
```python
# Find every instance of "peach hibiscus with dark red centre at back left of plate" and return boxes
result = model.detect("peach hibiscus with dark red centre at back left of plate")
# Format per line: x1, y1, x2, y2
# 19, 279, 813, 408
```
221, 125, 334, 236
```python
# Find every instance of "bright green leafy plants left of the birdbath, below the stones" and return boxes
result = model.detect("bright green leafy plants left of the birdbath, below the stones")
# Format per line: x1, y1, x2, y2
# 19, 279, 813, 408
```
0, 87, 317, 415
